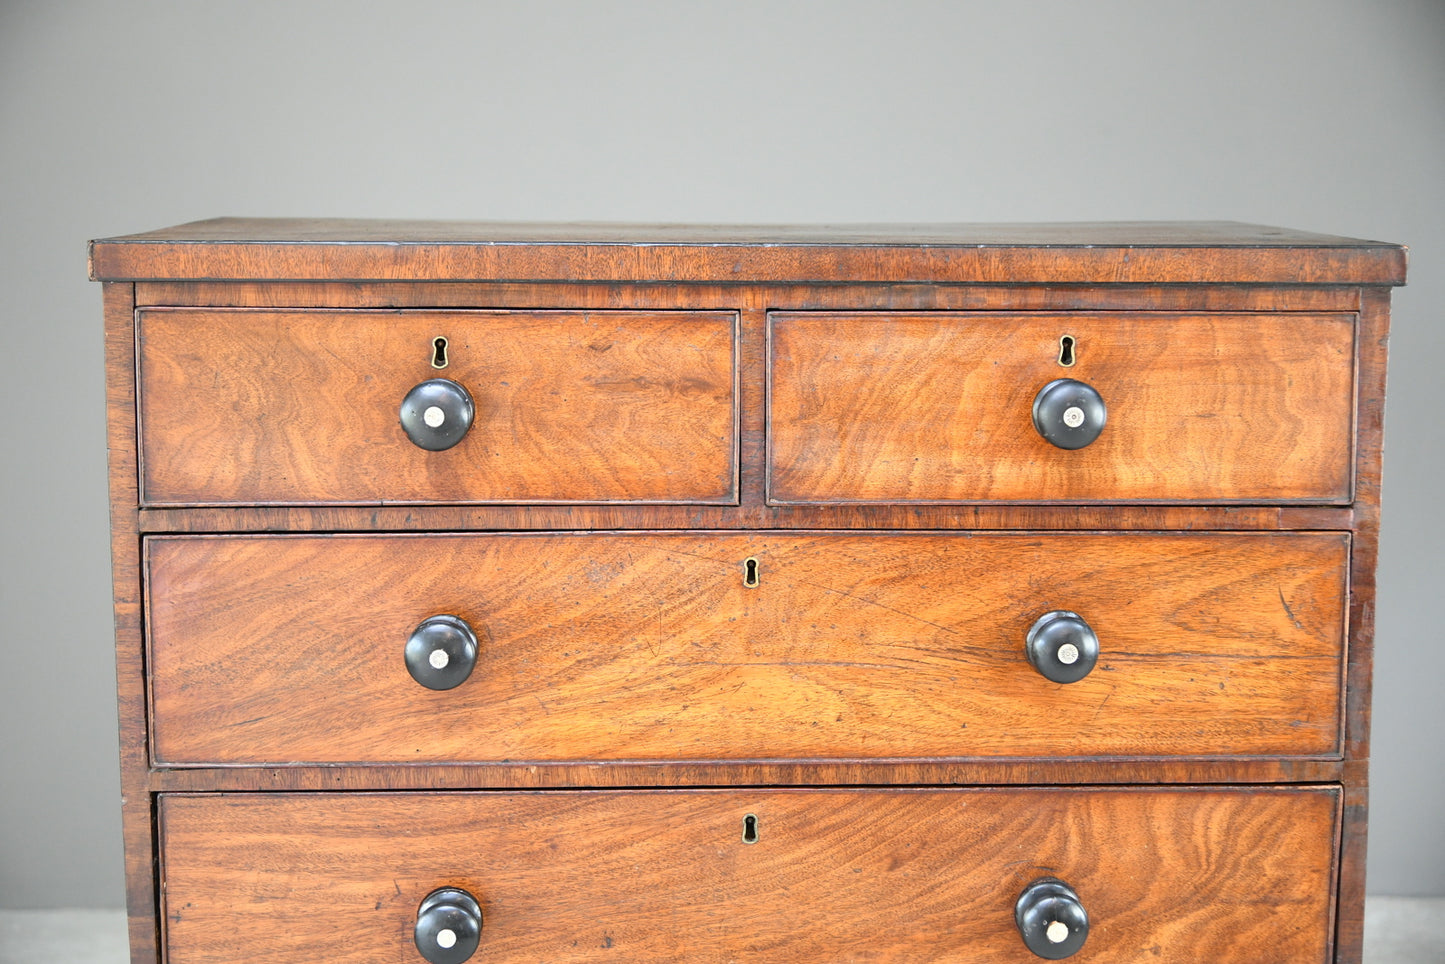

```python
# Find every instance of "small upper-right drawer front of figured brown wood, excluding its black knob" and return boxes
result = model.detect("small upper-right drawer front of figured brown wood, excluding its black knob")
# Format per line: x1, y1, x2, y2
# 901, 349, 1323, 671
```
769, 312, 1355, 503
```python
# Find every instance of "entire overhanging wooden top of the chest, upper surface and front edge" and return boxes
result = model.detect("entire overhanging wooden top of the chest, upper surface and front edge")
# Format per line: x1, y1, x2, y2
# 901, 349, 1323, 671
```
90, 218, 1405, 285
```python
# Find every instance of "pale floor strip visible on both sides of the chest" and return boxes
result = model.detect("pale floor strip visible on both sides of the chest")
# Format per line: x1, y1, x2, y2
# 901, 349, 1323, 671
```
0, 898, 1445, 964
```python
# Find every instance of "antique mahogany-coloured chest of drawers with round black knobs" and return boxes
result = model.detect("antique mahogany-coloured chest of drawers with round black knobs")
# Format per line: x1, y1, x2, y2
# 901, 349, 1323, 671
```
91, 220, 1405, 964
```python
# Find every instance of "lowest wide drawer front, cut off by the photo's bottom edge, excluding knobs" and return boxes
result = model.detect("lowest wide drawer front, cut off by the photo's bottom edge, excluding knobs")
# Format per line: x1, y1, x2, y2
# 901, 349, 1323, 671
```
160, 786, 1340, 964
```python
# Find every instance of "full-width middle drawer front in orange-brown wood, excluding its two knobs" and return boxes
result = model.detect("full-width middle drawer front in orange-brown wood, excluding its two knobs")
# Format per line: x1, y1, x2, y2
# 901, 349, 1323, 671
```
146, 533, 1350, 765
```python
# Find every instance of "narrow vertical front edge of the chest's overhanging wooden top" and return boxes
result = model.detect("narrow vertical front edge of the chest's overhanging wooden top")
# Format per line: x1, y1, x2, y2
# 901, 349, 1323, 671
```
91, 241, 1405, 285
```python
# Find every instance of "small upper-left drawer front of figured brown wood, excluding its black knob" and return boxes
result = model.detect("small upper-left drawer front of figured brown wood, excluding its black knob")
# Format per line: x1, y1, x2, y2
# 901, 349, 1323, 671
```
137, 309, 737, 506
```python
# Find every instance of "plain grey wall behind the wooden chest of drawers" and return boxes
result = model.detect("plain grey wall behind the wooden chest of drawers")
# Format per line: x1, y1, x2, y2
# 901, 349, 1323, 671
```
0, 0, 1445, 908
